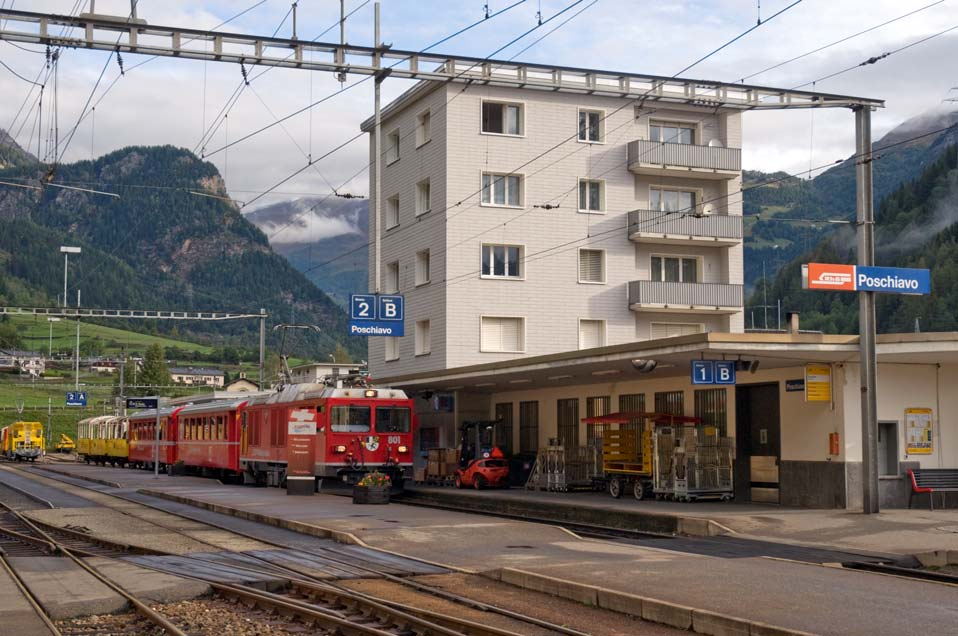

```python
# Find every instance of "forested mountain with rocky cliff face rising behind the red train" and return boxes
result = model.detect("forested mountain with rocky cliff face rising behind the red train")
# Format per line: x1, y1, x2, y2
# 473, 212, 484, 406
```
0, 137, 365, 359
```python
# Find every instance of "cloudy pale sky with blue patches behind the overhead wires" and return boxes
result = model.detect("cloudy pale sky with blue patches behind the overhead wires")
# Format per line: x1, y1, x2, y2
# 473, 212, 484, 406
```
0, 0, 958, 211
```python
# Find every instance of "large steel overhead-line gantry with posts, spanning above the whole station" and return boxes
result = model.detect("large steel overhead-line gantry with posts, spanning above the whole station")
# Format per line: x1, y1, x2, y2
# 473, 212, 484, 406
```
0, 2, 884, 514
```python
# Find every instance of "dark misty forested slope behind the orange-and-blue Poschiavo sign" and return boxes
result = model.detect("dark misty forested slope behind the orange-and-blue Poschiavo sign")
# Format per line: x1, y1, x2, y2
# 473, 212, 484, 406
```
753, 145, 958, 333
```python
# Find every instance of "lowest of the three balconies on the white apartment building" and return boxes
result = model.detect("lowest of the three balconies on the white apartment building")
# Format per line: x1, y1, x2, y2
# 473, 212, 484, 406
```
629, 280, 743, 314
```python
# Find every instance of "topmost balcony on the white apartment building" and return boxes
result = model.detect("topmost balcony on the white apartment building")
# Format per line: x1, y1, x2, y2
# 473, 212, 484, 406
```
629, 139, 742, 179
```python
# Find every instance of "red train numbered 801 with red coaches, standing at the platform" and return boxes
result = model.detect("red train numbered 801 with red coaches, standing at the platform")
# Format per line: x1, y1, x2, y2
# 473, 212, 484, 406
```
129, 384, 416, 487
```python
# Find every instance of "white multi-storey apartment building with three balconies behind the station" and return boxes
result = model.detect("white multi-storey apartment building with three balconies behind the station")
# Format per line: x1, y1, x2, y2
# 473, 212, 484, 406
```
363, 81, 744, 377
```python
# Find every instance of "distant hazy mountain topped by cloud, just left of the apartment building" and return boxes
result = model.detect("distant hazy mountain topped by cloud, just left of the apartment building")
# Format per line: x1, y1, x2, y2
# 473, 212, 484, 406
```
246, 197, 369, 307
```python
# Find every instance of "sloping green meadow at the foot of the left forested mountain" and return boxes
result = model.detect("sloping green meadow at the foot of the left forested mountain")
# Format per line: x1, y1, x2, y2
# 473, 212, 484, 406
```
10, 316, 213, 354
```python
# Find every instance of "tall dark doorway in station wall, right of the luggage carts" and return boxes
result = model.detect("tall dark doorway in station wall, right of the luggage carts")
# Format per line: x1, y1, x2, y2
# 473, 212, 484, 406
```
735, 382, 782, 504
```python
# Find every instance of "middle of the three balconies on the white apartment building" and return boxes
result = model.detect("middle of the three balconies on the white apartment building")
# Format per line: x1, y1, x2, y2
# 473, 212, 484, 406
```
629, 210, 742, 246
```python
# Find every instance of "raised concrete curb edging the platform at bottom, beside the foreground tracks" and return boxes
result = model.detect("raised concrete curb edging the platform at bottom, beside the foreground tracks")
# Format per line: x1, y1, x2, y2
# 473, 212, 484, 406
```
481, 568, 813, 636
